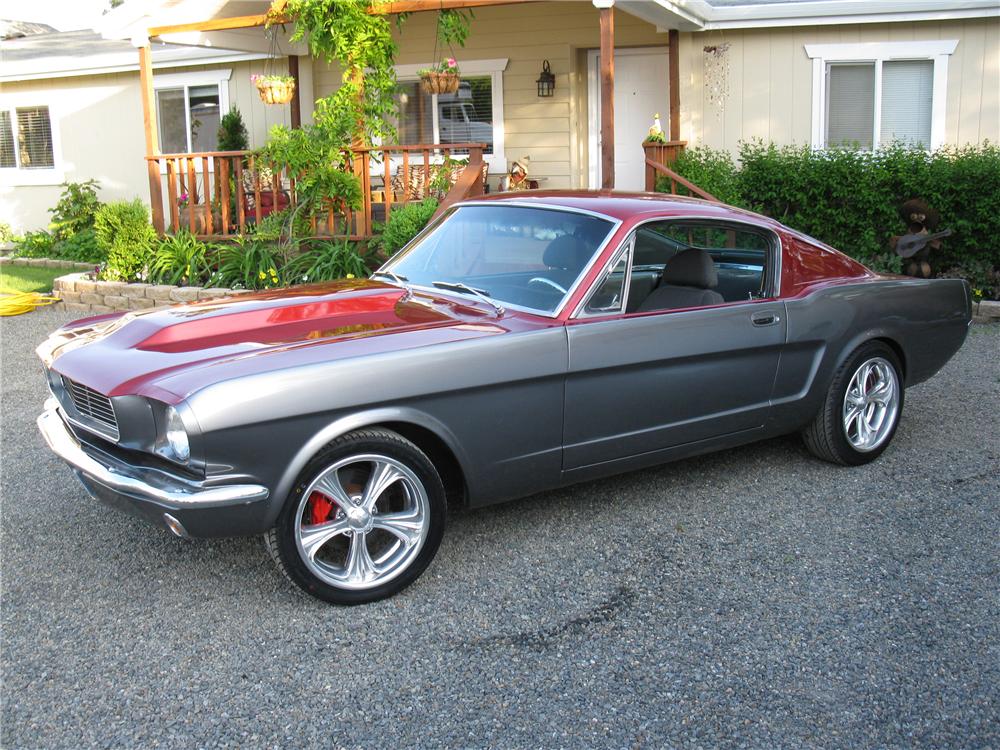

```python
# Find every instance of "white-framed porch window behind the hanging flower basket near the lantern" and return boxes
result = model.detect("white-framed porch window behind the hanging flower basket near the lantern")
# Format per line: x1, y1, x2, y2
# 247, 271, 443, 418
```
396, 60, 507, 171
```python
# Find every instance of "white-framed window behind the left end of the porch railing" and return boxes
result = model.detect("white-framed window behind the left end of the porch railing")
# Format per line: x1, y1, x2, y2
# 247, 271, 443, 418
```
153, 70, 230, 154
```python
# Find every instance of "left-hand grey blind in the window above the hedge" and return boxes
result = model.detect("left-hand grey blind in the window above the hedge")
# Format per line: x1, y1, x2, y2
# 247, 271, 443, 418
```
826, 63, 875, 149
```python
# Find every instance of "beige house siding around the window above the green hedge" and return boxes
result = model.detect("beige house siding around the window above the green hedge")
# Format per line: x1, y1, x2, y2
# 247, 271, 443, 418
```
680, 19, 1000, 152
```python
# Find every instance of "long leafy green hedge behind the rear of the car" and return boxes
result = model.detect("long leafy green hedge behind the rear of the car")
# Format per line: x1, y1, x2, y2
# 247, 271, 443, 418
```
657, 141, 1000, 298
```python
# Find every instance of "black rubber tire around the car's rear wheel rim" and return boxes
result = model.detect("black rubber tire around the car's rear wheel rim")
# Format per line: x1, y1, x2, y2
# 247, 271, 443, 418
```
802, 341, 905, 466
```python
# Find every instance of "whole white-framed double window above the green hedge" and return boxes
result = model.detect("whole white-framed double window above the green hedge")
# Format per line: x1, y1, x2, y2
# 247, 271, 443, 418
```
806, 40, 958, 149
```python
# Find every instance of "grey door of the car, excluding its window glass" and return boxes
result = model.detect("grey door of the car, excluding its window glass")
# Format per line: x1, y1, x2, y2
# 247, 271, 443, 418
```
563, 220, 785, 470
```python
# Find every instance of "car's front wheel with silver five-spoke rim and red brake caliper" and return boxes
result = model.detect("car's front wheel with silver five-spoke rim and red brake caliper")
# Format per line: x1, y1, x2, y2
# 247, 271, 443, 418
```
265, 429, 446, 604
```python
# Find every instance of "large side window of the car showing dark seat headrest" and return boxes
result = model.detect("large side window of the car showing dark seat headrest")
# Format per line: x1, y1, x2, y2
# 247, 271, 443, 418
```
627, 220, 773, 313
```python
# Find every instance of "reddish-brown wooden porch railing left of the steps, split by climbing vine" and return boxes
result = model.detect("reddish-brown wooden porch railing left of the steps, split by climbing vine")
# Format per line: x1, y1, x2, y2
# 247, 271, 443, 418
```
146, 143, 486, 240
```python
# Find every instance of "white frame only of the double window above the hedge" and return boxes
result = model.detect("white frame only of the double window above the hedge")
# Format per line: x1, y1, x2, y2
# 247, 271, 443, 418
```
805, 39, 958, 149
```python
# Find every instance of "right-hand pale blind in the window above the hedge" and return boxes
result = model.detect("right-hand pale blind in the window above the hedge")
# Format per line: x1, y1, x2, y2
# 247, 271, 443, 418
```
879, 60, 934, 146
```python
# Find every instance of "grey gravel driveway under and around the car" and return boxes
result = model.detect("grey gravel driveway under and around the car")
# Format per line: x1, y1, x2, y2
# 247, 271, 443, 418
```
0, 310, 1000, 749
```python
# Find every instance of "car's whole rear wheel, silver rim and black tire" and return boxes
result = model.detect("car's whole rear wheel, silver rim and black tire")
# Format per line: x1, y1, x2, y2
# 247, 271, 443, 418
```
802, 341, 903, 466
